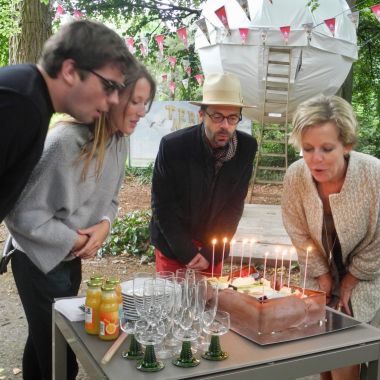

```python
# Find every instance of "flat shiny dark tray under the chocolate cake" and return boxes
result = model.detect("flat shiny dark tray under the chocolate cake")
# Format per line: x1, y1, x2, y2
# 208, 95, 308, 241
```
231, 307, 361, 346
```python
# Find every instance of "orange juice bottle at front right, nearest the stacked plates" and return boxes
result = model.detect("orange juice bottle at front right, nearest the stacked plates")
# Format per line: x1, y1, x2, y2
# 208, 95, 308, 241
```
99, 284, 119, 340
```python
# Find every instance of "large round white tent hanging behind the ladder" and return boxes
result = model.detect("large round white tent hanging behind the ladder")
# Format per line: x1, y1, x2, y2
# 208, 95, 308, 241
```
195, 0, 358, 120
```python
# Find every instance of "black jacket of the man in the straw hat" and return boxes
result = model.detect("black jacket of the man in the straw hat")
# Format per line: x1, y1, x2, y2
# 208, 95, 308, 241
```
150, 125, 257, 264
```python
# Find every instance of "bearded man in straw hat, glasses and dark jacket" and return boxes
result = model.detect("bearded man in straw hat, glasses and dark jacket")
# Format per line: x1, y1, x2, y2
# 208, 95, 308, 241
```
150, 73, 257, 275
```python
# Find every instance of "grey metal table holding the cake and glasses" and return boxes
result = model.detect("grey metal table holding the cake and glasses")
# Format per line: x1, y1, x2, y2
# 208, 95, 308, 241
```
53, 309, 380, 380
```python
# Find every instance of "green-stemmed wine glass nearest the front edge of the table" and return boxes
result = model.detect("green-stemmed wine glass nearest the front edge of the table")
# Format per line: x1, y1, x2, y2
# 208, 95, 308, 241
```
135, 320, 165, 372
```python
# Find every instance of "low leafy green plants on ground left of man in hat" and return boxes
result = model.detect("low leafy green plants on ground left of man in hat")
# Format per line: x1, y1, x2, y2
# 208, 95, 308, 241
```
98, 211, 154, 258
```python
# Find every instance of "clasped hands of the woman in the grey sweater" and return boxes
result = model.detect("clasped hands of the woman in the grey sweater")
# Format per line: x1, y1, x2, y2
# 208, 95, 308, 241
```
73, 220, 110, 259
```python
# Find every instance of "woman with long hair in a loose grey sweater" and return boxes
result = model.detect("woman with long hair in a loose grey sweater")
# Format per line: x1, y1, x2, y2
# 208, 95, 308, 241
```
6, 66, 155, 380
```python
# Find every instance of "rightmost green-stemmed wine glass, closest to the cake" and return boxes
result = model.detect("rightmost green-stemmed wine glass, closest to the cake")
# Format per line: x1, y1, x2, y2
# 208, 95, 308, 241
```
202, 310, 230, 361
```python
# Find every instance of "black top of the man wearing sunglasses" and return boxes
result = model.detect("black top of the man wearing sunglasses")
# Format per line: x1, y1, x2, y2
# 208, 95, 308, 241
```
0, 65, 54, 221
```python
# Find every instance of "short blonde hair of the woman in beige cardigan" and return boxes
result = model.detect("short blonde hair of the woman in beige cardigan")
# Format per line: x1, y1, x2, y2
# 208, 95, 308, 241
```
289, 94, 358, 148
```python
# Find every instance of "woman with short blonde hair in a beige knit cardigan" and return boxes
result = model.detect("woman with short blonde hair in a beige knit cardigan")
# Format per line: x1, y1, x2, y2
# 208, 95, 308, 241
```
282, 95, 380, 380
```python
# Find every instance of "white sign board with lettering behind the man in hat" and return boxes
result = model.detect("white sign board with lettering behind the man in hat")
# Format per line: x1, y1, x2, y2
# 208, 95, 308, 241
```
129, 101, 251, 167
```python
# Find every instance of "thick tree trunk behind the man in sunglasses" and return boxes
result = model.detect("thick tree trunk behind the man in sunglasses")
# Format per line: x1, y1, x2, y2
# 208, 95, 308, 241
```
9, 0, 51, 64
